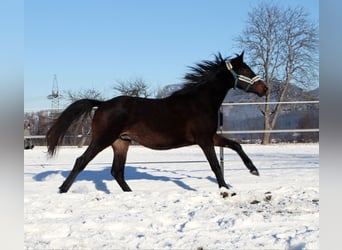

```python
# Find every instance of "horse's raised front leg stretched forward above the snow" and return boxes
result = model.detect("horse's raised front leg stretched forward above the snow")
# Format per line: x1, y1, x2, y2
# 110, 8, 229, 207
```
213, 134, 259, 175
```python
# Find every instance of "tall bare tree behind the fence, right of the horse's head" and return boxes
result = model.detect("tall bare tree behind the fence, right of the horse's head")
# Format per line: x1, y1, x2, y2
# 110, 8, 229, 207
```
236, 3, 318, 144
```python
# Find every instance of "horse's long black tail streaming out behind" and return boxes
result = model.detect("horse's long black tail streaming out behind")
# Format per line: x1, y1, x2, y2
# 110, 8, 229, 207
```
46, 99, 103, 156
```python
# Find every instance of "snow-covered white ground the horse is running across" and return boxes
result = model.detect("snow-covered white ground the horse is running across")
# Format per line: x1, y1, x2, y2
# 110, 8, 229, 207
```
24, 144, 319, 250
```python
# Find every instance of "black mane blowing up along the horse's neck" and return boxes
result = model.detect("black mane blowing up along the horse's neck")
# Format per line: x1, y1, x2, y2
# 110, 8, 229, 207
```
172, 53, 227, 95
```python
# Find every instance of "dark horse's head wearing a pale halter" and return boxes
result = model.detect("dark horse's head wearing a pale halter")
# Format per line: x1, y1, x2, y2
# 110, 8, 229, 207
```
226, 52, 268, 97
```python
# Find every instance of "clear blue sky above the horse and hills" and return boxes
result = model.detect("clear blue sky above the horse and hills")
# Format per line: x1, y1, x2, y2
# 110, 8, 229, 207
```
24, 0, 319, 110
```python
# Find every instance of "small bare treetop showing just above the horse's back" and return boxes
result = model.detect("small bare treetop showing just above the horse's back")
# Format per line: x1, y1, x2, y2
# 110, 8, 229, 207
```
113, 78, 151, 98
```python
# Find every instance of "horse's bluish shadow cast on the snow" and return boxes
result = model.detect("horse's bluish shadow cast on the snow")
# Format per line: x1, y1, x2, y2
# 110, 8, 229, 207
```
33, 166, 216, 194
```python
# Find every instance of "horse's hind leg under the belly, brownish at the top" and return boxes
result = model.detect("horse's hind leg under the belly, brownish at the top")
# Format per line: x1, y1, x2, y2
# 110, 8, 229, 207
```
111, 139, 132, 192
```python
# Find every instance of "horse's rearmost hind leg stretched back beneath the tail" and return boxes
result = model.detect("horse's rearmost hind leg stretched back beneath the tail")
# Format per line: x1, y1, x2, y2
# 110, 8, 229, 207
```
59, 142, 105, 193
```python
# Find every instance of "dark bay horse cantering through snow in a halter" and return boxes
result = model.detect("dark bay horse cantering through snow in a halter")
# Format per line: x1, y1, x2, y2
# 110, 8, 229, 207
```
46, 53, 267, 193
